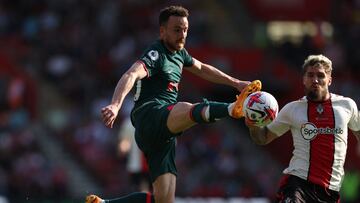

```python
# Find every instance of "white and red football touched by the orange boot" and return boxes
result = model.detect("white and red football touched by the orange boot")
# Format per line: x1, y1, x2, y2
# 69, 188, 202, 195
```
243, 91, 279, 127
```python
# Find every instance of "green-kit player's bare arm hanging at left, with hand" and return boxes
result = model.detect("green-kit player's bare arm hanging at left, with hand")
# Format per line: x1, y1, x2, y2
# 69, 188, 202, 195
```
101, 62, 147, 128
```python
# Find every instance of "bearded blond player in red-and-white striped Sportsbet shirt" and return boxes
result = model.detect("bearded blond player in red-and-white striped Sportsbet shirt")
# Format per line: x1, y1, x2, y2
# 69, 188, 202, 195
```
246, 55, 360, 203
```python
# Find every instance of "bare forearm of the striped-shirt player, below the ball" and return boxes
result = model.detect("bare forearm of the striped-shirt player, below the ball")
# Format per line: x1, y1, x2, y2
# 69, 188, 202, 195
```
247, 124, 277, 145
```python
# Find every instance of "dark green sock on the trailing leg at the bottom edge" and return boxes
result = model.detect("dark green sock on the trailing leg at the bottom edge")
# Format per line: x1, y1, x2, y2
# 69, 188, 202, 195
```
105, 192, 155, 203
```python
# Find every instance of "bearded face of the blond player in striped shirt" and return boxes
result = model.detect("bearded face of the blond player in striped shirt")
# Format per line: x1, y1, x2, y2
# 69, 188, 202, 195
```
303, 65, 331, 101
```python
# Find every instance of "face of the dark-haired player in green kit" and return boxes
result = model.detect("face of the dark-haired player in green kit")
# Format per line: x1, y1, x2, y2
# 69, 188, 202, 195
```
160, 16, 189, 51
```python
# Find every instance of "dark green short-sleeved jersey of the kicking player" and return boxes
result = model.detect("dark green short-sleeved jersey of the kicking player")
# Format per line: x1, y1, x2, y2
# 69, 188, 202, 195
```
134, 40, 194, 107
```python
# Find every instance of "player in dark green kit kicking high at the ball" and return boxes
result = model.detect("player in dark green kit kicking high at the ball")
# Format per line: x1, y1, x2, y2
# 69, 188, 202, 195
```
86, 6, 261, 203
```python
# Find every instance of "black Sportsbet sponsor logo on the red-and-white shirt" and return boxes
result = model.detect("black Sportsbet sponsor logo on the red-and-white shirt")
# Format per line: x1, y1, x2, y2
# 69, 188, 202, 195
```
300, 122, 344, 140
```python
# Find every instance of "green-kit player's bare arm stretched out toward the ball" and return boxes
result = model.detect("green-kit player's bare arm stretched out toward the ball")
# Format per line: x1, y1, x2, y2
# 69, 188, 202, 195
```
187, 58, 250, 91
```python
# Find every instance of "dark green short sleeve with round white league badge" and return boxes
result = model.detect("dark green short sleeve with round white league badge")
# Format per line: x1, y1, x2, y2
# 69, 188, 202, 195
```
140, 49, 163, 77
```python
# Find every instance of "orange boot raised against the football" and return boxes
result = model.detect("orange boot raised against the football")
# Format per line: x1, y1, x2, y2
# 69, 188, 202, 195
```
231, 80, 261, 118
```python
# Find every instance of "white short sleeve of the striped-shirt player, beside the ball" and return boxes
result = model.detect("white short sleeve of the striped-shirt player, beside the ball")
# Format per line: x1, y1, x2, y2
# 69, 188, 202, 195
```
266, 104, 292, 137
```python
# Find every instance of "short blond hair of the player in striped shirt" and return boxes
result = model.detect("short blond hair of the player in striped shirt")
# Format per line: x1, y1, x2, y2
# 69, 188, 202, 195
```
302, 54, 332, 74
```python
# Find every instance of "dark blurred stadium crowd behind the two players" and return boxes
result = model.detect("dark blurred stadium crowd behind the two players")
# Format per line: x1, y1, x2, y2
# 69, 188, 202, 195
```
0, 0, 360, 203
